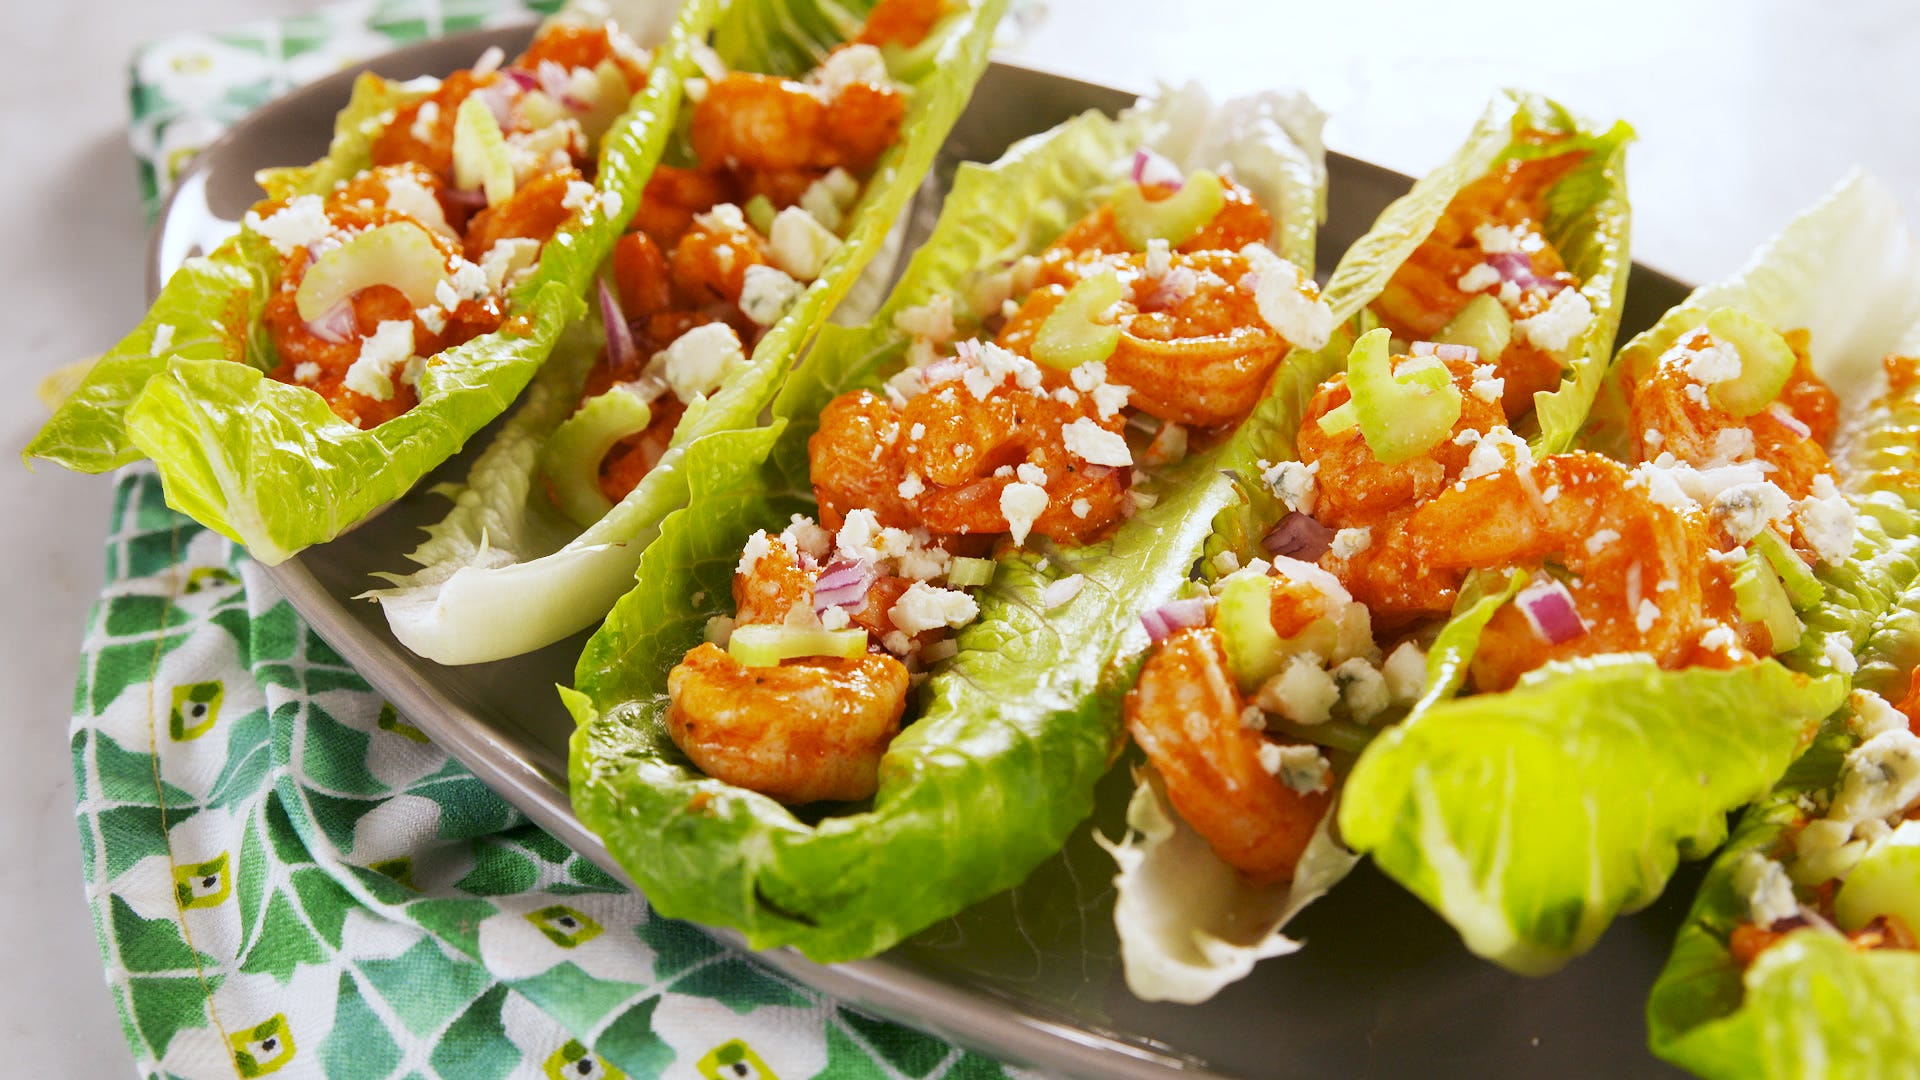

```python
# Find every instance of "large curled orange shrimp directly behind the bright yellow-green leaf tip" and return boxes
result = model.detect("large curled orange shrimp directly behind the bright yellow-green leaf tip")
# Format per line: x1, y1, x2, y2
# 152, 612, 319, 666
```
1405, 454, 1707, 690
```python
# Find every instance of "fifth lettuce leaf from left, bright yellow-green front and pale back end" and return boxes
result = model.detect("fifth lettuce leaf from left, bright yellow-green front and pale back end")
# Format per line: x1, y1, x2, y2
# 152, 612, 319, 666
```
1340, 177, 1916, 974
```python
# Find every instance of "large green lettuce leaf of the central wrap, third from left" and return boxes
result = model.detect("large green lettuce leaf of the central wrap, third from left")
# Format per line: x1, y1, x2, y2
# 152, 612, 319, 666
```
563, 90, 1325, 961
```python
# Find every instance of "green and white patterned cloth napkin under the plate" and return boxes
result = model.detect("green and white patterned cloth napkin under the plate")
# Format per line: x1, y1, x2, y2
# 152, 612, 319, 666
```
86, 0, 1052, 1080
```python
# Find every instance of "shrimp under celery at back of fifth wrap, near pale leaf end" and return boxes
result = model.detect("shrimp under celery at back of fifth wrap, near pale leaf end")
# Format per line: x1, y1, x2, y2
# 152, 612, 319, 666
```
1632, 331, 1839, 498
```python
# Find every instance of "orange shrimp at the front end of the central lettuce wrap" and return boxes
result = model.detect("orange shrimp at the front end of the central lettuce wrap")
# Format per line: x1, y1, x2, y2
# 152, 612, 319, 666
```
666, 644, 908, 805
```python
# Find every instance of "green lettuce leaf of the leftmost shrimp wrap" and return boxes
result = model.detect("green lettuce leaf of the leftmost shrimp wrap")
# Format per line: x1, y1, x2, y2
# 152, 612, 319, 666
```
27, 0, 720, 565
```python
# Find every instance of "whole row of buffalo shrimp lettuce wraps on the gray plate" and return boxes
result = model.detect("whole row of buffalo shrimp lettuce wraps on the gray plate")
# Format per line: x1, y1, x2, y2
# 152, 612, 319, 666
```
27, 0, 1920, 1076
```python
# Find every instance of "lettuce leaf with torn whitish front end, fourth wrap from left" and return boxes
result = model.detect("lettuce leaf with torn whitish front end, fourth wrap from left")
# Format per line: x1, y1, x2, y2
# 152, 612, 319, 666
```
1112, 92, 1632, 1001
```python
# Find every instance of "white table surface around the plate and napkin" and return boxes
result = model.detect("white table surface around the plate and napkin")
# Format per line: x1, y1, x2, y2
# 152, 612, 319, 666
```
11, 0, 1920, 1076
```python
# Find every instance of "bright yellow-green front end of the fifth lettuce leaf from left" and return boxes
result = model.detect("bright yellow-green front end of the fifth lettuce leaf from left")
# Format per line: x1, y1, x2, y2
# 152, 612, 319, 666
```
1340, 657, 1847, 974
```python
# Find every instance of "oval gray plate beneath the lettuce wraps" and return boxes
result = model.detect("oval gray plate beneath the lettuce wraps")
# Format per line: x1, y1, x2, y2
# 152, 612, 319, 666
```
152, 27, 1699, 1080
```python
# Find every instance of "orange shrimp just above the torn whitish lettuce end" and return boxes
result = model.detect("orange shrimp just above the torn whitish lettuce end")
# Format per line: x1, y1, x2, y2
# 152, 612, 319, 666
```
1125, 628, 1332, 882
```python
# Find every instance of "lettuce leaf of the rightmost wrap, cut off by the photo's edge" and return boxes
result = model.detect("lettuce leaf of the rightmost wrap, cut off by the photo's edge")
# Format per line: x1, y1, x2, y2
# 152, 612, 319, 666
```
1647, 311, 1920, 1076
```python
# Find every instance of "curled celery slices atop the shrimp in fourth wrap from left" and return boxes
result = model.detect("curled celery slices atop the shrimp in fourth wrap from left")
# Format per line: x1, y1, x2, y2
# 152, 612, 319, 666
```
1344, 327, 1461, 465
